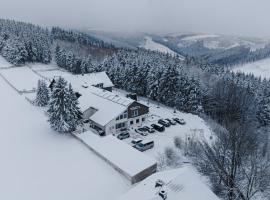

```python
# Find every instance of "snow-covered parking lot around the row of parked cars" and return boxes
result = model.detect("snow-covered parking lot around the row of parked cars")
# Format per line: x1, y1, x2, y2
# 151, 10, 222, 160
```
110, 90, 215, 158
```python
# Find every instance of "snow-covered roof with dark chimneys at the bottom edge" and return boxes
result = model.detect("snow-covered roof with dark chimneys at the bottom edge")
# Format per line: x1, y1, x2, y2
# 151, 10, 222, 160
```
118, 167, 220, 200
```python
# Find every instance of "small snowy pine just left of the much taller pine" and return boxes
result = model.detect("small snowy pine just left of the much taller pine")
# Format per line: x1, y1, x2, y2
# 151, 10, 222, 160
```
35, 80, 50, 107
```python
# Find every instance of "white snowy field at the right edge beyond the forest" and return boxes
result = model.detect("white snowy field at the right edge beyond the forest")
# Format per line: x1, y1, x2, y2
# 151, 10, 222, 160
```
233, 58, 270, 79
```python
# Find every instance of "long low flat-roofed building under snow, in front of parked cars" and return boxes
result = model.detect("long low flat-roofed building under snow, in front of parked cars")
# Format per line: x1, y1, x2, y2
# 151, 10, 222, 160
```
74, 131, 157, 184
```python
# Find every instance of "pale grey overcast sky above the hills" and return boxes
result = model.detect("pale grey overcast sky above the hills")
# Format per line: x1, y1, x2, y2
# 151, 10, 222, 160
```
0, 0, 270, 38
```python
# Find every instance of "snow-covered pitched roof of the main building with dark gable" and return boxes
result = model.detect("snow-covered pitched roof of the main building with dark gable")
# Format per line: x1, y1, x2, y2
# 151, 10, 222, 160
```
78, 86, 134, 126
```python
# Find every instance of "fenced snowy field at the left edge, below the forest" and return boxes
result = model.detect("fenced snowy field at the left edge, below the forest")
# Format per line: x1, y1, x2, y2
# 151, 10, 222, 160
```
0, 66, 40, 92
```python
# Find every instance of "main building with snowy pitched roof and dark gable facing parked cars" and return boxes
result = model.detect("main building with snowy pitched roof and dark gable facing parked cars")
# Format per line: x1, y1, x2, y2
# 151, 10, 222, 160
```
79, 86, 149, 135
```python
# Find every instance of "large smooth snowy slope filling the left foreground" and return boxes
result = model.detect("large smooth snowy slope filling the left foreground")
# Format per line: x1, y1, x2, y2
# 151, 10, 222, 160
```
0, 78, 130, 200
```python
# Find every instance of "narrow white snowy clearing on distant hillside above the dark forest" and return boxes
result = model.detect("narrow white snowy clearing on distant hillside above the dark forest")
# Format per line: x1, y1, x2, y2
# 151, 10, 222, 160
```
141, 36, 179, 55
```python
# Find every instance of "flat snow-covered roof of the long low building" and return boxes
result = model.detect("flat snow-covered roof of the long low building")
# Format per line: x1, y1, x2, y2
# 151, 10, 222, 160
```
77, 134, 156, 177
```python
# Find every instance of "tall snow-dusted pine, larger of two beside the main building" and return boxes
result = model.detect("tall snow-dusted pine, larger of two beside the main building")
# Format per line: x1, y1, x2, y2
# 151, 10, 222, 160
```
48, 77, 79, 133
